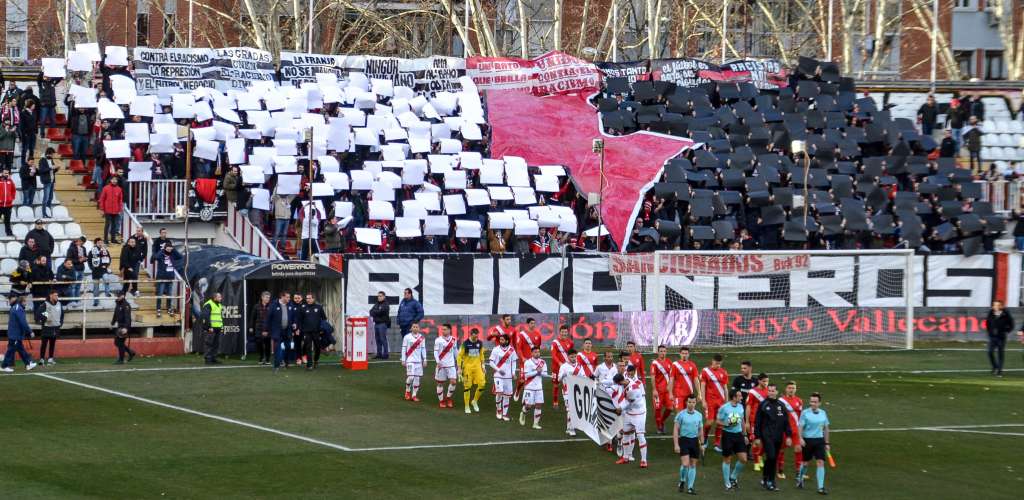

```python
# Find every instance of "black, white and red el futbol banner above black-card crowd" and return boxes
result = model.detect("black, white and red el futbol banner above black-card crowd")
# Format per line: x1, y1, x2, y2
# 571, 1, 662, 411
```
650, 57, 786, 89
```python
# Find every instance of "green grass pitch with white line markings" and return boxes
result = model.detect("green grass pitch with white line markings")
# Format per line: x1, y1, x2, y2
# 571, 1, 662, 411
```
0, 344, 1024, 500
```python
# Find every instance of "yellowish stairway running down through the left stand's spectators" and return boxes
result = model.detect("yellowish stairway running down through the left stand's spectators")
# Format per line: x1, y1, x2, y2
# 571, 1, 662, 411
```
0, 115, 180, 337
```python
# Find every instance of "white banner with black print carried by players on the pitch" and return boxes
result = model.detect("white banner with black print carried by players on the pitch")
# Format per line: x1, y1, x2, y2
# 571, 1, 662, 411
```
565, 375, 623, 445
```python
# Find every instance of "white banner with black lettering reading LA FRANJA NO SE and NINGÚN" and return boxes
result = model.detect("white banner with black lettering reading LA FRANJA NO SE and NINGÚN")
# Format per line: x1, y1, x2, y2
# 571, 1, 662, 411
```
281, 52, 466, 92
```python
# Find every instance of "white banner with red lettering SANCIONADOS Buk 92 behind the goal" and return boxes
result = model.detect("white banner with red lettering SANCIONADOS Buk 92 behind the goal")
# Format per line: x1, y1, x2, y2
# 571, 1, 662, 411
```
608, 253, 811, 276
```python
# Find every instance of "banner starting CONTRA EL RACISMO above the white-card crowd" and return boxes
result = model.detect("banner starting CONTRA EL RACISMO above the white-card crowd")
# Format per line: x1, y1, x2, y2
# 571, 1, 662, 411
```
133, 47, 274, 95
